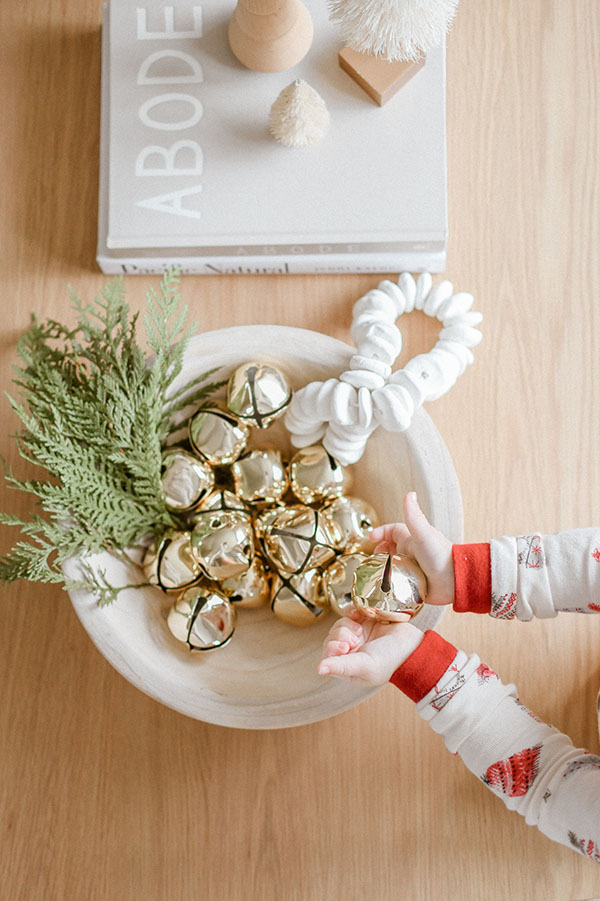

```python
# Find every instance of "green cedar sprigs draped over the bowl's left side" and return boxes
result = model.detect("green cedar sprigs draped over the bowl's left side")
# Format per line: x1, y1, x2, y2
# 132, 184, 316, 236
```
0, 270, 223, 604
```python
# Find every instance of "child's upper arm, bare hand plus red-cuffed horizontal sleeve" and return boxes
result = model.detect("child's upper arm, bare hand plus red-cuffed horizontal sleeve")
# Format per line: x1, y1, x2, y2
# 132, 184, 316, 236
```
372, 494, 600, 620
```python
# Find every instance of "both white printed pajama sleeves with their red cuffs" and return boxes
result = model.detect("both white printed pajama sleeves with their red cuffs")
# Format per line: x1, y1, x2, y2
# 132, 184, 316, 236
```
390, 529, 600, 863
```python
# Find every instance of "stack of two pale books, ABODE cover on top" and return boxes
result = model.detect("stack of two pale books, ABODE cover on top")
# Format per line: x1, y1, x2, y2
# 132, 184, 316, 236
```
98, 0, 447, 274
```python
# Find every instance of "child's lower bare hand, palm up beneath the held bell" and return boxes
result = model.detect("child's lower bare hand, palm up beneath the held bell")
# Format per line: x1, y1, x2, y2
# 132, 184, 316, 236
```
318, 610, 423, 685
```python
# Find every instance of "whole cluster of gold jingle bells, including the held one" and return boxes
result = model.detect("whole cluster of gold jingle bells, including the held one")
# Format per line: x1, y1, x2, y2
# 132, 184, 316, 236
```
143, 362, 426, 650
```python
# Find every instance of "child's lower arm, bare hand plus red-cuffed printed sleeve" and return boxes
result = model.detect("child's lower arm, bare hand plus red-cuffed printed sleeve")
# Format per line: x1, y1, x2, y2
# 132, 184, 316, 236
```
319, 614, 600, 863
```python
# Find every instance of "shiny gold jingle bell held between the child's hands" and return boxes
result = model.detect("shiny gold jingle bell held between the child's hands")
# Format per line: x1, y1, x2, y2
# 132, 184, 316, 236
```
352, 554, 427, 623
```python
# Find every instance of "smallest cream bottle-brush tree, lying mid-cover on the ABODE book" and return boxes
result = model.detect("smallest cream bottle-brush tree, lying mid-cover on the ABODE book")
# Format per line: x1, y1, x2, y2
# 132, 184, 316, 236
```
269, 78, 329, 147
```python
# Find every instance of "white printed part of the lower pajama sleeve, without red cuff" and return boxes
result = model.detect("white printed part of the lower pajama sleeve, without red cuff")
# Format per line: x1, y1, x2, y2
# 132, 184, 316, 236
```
417, 651, 600, 863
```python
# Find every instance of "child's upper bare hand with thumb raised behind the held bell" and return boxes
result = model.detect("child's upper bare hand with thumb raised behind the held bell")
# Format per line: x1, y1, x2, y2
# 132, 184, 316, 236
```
369, 491, 454, 605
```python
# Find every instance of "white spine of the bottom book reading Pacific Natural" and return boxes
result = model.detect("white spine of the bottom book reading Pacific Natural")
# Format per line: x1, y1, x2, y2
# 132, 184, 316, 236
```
96, 251, 446, 275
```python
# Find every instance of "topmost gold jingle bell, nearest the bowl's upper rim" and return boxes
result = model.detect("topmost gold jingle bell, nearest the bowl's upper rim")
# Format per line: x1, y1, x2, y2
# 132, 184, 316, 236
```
227, 362, 292, 429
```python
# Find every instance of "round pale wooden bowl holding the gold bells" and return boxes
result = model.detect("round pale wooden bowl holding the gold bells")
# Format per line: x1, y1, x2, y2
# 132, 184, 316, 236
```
67, 325, 462, 729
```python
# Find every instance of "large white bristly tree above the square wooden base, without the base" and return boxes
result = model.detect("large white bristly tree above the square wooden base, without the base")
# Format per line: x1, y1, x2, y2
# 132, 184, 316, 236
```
328, 0, 458, 60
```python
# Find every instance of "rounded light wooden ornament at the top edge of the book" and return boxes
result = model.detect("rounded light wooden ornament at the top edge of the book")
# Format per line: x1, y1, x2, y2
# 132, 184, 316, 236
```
228, 0, 313, 72
